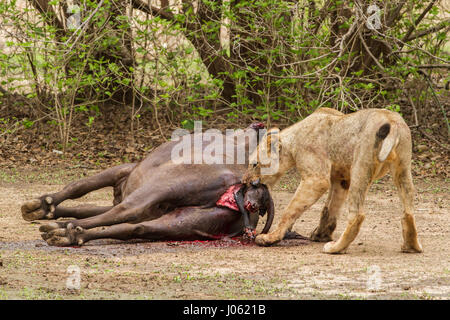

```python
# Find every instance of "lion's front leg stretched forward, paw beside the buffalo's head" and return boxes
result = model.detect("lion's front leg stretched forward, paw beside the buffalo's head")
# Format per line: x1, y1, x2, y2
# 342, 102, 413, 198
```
255, 176, 330, 246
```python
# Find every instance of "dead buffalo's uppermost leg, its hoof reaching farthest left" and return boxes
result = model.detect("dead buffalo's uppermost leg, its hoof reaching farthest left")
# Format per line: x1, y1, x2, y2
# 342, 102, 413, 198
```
21, 163, 136, 221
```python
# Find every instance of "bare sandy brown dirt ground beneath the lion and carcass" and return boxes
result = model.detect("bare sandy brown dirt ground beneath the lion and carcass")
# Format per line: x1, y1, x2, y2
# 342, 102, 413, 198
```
0, 170, 450, 300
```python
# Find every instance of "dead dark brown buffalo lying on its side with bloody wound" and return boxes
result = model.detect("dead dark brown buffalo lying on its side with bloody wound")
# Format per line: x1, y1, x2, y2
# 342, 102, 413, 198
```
21, 123, 274, 246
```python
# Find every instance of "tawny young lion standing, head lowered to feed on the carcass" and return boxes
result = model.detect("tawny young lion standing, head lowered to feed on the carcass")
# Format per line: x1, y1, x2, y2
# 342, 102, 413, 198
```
244, 108, 422, 253
